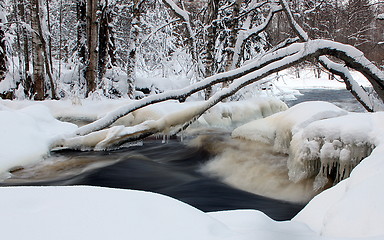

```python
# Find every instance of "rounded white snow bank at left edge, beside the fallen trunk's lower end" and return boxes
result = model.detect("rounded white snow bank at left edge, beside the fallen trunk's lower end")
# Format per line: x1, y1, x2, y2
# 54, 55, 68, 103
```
0, 105, 76, 177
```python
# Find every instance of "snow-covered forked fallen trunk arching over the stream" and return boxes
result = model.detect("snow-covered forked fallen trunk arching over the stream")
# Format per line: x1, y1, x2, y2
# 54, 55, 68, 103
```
55, 40, 384, 147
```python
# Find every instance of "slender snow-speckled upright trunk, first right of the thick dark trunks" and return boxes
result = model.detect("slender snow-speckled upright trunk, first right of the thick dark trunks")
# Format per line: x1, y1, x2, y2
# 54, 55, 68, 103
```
127, 0, 142, 99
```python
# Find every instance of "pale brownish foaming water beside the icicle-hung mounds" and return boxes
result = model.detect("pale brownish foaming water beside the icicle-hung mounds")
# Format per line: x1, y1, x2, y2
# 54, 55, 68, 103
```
192, 135, 322, 203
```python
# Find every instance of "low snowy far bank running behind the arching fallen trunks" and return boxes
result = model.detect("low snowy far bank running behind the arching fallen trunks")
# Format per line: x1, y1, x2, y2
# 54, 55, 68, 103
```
1, 97, 287, 128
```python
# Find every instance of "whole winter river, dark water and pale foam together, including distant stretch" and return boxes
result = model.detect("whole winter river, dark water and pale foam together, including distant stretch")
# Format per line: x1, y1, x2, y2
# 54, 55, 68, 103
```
2, 89, 363, 220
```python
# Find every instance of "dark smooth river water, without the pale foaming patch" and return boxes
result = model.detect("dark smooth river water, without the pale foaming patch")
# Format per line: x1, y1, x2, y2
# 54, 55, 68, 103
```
1, 90, 360, 220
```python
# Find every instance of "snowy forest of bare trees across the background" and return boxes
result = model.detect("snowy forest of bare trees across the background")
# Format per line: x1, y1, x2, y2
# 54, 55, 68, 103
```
0, 0, 384, 100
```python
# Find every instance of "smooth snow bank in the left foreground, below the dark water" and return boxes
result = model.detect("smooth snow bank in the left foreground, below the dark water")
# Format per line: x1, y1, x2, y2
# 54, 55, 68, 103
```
0, 187, 235, 240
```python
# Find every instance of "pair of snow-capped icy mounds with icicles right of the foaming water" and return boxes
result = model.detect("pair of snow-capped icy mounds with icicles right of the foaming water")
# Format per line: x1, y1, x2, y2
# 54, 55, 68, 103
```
232, 102, 376, 191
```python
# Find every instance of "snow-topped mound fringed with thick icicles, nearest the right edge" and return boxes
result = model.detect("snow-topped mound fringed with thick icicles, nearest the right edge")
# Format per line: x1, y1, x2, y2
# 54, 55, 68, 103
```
288, 113, 375, 190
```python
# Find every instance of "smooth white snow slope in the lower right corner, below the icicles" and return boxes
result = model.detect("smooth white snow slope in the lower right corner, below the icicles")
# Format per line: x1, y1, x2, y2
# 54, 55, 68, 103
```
293, 112, 384, 239
